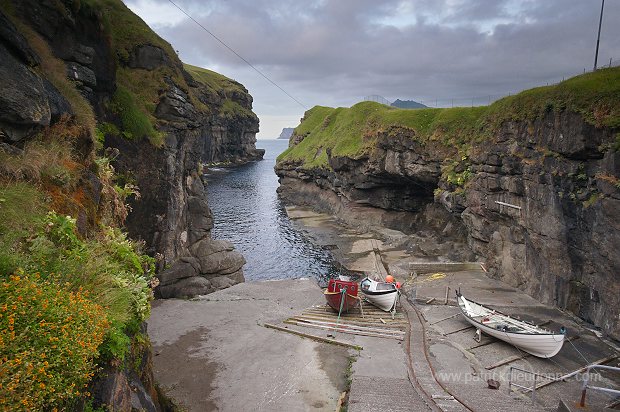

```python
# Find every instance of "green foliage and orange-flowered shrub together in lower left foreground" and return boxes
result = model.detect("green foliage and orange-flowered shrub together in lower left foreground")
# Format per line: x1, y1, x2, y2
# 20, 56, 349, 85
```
0, 182, 154, 410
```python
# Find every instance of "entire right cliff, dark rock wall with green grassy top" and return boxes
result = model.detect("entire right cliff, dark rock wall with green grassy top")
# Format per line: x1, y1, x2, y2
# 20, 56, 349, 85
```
276, 68, 620, 339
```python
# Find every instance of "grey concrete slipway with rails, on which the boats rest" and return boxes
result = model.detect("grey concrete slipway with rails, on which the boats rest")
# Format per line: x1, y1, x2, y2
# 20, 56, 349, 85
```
148, 211, 620, 411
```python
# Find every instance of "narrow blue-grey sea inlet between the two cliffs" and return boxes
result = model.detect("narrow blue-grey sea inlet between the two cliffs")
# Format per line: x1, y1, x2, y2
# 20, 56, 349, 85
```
206, 139, 337, 281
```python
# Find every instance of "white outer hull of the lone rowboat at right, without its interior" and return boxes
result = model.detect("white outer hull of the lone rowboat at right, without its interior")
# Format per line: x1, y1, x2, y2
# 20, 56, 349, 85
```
457, 296, 564, 358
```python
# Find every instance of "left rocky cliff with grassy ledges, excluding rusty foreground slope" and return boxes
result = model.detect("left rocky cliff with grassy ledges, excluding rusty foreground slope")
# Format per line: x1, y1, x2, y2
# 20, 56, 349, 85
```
0, 0, 263, 297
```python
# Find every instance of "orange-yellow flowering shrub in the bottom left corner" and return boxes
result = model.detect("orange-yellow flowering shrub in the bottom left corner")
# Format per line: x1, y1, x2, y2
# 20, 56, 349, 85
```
0, 272, 109, 410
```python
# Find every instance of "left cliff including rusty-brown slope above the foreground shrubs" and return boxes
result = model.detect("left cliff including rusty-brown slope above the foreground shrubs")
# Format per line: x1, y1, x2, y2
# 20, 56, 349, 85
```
0, 0, 263, 410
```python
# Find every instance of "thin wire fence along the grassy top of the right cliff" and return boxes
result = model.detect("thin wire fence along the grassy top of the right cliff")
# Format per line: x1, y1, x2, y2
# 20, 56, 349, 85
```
364, 58, 620, 108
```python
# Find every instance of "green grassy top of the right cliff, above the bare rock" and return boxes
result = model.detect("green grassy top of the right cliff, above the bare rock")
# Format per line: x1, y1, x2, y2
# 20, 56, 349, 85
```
278, 67, 620, 167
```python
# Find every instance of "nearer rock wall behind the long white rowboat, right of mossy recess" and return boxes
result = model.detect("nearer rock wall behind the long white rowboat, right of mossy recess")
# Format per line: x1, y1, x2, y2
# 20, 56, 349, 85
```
461, 113, 620, 339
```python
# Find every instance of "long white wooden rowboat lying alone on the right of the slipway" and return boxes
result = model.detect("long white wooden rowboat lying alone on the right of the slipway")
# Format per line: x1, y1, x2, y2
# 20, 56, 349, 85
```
456, 292, 564, 358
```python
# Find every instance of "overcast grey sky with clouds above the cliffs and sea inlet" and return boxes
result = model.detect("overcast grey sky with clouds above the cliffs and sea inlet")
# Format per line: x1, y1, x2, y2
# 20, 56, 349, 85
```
124, 0, 620, 139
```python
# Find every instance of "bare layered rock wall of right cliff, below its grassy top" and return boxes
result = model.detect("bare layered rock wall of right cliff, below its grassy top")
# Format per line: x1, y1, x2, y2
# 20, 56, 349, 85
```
276, 83, 620, 339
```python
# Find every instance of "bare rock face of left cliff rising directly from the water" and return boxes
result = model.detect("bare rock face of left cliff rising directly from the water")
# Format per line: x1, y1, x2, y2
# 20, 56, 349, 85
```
111, 71, 263, 298
